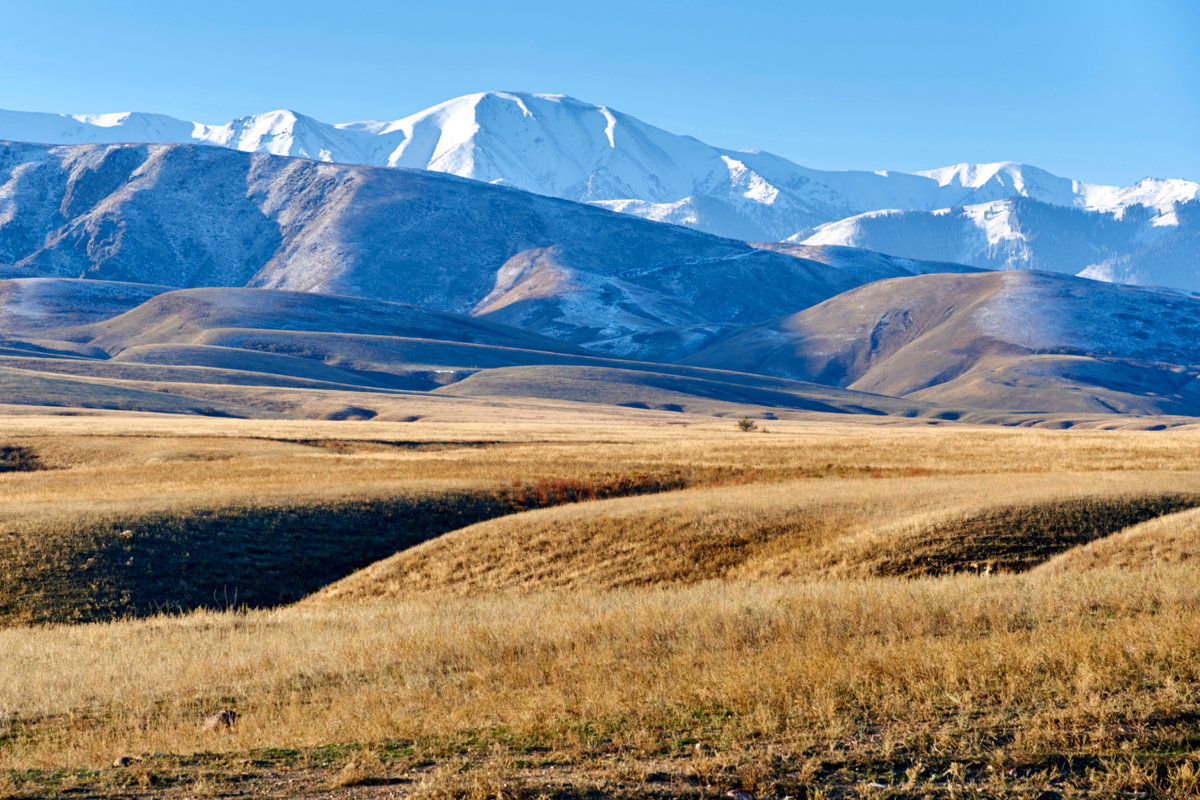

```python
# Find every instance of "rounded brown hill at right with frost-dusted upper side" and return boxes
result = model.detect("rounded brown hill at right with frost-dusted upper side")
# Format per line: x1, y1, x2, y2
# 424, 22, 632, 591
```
684, 271, 1200, 415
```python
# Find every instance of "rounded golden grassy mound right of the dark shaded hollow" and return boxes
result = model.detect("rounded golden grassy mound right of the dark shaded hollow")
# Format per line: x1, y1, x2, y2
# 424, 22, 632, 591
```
314, 473, 1200, 602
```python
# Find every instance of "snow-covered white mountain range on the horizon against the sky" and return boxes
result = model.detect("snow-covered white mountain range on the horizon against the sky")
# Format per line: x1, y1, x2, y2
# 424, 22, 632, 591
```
0, 91, 1200, 289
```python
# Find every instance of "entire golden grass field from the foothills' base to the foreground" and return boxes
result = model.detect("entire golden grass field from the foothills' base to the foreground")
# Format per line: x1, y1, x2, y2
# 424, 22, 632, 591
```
0, 401, 1200, 800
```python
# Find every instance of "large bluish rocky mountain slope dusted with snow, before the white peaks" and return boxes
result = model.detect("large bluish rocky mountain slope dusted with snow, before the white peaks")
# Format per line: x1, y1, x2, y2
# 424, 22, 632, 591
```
0, 144, 966, 357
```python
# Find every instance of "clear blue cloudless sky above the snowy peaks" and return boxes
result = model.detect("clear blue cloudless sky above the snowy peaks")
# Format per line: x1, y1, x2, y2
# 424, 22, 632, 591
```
0, 0, 1200, 184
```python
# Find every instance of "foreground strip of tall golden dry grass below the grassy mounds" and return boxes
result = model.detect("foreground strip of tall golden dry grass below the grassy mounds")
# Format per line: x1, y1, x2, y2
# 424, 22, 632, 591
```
7, 567, 1200, 792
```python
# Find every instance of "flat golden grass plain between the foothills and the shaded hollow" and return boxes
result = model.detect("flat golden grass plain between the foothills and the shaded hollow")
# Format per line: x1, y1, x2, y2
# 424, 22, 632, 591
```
7, 411, 1200, 519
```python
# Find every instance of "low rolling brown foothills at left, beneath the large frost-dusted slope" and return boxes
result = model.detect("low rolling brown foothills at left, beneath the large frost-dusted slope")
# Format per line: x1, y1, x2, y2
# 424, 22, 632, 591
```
0, 279, 954, 416
